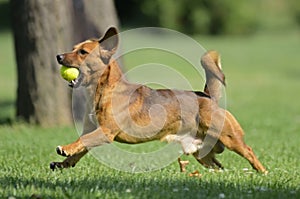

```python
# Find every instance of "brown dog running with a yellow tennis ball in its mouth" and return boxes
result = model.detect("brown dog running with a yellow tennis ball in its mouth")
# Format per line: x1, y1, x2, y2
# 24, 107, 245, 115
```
50, 28, 267, 173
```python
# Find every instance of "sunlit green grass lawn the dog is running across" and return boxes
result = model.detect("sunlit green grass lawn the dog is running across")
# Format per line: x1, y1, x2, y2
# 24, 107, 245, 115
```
0, 26, 300, 198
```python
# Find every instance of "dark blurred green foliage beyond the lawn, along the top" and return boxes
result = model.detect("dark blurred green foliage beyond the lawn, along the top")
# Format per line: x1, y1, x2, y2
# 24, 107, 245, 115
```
116, 0, 300, 35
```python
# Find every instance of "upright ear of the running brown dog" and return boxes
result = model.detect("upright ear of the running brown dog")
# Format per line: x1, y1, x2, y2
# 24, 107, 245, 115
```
99, 27, 119, 64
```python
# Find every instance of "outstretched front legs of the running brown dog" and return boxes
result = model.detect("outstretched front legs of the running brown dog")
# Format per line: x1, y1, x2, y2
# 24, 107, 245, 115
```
50, 127, 115, 170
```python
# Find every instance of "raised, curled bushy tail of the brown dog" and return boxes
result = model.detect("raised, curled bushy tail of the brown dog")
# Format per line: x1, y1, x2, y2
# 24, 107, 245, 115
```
201, 51, 226, 103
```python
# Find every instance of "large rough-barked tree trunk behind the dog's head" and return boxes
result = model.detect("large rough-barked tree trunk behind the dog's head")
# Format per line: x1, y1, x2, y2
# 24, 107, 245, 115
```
11, 0, 117, 126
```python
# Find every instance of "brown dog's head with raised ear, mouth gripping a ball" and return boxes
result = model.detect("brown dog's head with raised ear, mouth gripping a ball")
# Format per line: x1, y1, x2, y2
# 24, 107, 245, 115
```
56, 27, 119, 88
